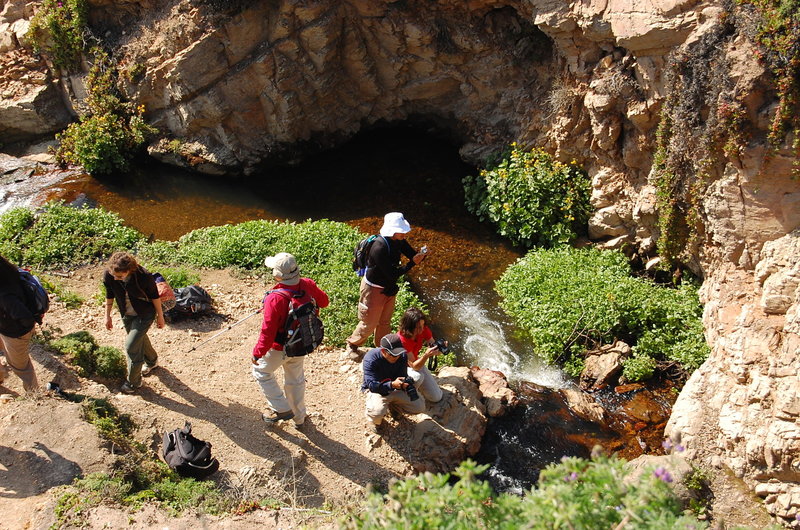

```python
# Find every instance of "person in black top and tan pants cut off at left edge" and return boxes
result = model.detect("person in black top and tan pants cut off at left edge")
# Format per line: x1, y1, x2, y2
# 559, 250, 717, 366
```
0, 256, 39, 392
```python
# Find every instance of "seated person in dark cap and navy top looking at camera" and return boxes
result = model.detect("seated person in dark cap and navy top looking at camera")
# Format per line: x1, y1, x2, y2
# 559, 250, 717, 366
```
361, 333, 425, 433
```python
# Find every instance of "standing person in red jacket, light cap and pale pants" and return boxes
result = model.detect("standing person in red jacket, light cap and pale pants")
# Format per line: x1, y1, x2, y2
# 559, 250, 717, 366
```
252, 252, 329, 427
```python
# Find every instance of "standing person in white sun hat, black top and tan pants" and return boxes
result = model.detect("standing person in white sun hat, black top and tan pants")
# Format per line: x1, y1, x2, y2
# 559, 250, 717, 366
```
347, 212, 427, 362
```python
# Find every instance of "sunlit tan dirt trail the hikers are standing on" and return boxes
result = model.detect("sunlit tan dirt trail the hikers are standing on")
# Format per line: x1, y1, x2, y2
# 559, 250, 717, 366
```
0, 266, 411, 528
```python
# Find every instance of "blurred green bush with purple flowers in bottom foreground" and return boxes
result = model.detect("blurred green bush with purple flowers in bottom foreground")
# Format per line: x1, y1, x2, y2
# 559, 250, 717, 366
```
342, 458, 706, 530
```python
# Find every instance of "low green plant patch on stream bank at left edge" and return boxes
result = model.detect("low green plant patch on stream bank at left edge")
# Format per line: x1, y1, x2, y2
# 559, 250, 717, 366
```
0, 202, 143, 267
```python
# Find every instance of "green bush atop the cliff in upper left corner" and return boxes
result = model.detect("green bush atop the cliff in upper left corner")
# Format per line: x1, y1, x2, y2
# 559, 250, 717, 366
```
25, 0, 86, 71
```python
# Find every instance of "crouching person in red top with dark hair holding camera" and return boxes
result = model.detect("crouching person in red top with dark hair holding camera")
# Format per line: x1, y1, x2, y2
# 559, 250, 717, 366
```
398, 307, 450, 403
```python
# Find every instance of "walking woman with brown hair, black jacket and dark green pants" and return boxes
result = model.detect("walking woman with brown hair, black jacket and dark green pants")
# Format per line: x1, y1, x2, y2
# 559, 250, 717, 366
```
103, 252, 164, 394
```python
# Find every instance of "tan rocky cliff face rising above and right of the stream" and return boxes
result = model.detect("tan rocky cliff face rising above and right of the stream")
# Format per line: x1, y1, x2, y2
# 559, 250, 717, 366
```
0, 0, 800, 517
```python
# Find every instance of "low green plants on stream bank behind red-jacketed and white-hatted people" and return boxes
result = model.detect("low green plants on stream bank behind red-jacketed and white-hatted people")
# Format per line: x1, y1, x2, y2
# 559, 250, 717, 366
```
140, 220, 422, 345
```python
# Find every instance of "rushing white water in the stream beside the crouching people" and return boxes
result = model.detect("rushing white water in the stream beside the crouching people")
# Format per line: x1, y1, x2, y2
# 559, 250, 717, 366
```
434, 289, 569, 388
